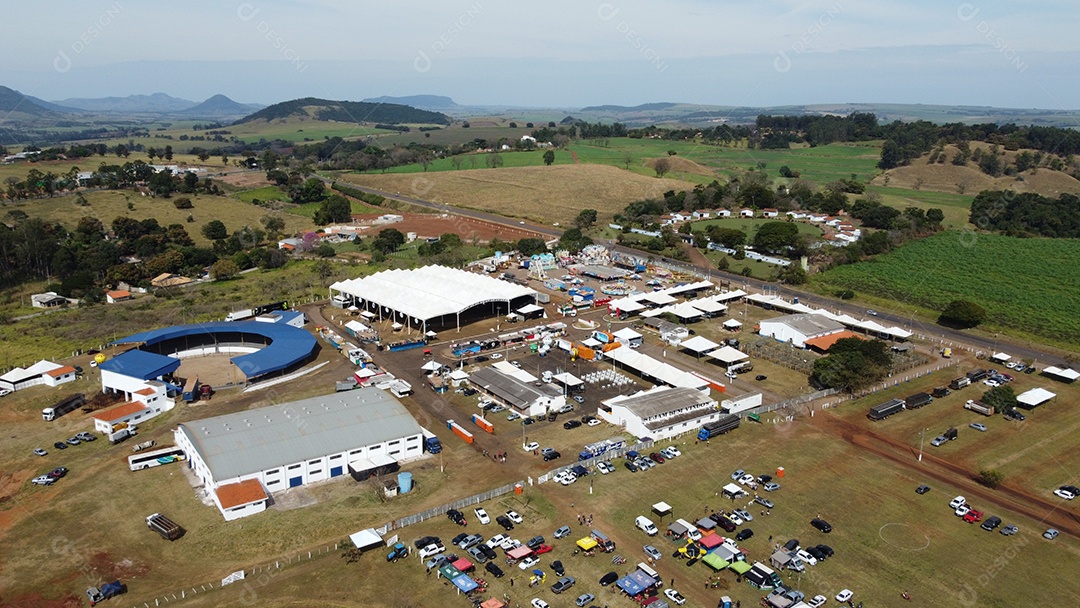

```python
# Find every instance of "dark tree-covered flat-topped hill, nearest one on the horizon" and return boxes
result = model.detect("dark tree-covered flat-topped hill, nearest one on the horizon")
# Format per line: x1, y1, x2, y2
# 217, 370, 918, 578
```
237, 97, 450, 124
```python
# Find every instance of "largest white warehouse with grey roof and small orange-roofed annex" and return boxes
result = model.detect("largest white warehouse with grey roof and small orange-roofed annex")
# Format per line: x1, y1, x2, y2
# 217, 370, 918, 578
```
174, 388, 423, 521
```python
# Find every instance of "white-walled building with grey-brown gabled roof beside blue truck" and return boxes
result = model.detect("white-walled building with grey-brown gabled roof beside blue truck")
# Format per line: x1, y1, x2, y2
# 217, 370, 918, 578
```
597, 387, 720, 440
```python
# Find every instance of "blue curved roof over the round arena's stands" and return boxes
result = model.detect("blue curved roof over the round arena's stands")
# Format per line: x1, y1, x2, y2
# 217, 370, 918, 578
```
113, 321, 315, 378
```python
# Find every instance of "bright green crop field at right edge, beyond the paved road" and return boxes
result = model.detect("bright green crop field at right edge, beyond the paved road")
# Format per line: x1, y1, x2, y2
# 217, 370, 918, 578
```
813, 231, 1080, 349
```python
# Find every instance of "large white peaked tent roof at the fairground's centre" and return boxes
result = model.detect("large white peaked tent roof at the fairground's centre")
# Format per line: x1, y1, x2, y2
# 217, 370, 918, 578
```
330, 266, 536, 321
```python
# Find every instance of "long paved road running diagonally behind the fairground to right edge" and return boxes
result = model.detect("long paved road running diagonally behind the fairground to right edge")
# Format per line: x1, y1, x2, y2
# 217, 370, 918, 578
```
330, 177, 1062, 365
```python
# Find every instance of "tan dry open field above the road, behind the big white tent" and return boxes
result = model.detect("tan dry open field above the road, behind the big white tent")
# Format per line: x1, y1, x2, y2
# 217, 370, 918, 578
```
341, 164, 693, 224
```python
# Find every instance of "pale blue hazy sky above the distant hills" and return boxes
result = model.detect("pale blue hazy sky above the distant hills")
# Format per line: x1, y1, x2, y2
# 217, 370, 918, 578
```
0, 0, 1080, 109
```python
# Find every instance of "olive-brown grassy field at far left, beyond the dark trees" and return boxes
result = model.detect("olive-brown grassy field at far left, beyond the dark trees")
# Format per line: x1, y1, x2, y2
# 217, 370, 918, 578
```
4, 190, 313, 246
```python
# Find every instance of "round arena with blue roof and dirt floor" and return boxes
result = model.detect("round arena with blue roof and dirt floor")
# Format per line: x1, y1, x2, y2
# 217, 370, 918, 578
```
110, 321, 319, 386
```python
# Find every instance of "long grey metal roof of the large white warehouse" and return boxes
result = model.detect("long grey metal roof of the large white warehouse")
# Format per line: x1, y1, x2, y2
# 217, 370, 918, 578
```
178, 388, 421, 481
